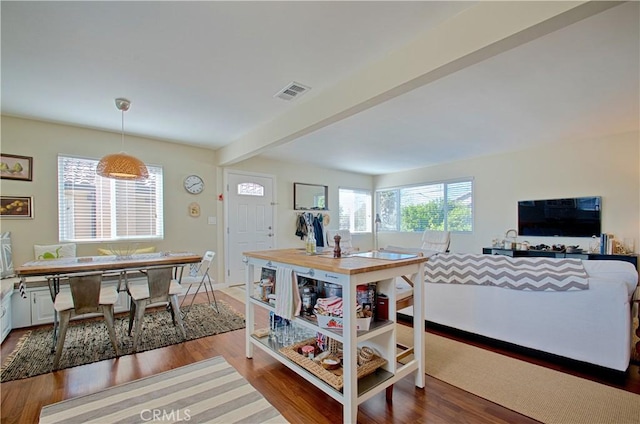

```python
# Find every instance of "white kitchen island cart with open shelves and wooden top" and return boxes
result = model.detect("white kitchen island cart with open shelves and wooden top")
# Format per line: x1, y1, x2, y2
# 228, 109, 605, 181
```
245, 249, 426, 423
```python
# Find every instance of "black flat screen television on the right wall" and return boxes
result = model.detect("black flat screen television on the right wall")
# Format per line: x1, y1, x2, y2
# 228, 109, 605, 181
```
518, 196, 602, 237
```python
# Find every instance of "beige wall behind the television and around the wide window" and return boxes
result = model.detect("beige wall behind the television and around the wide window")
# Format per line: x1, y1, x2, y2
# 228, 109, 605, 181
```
374, 132, 640, 253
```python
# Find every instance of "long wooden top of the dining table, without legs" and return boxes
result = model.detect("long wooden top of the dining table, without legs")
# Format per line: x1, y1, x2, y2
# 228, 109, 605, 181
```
14, 252, 202, 277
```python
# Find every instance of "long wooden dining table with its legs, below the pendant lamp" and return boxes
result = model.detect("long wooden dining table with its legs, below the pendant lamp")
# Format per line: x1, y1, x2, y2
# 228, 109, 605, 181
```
14, 252, 202, 346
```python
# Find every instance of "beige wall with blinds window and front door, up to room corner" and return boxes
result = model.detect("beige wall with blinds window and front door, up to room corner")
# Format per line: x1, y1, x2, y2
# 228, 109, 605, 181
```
0, 116, 373, 282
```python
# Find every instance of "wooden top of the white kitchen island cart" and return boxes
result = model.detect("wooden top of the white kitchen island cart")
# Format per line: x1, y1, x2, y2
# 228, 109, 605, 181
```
243, 249, 427, 274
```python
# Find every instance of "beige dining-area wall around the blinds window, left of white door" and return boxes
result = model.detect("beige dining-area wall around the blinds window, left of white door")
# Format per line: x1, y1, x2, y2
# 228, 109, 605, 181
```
0, 116, 218, 266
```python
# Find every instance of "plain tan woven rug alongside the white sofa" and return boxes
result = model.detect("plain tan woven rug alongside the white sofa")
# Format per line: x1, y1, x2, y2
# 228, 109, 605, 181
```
397, 325, 640, 424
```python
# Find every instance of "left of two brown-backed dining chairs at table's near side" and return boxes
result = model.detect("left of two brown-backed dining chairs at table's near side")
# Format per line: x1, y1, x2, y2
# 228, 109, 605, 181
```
53, 272, 120, 370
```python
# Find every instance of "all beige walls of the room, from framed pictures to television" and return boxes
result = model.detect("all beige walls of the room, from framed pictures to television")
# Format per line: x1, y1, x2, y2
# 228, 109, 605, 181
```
0, 116, 640, 281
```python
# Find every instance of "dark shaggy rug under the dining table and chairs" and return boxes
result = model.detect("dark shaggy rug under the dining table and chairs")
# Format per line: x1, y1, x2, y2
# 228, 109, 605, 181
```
0, 300, 245, 382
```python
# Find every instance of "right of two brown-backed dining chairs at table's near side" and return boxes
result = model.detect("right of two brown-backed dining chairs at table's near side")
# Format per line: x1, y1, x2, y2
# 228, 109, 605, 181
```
127, 266, 187, 352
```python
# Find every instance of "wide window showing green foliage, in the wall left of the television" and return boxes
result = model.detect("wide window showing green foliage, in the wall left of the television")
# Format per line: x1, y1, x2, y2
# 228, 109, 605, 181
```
376, 180, 473, 232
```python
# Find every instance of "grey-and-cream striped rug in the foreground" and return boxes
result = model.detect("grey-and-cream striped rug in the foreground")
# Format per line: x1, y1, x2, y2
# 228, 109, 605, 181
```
40, 356, 287, 424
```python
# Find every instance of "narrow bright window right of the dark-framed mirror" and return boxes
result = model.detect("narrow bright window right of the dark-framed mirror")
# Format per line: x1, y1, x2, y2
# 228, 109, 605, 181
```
338, 188, 372, 233
